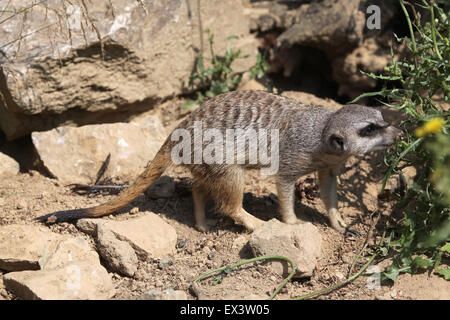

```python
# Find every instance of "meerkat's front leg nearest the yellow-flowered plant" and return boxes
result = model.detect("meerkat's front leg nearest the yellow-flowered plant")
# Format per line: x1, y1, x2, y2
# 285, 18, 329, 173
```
319, 168, 348, 233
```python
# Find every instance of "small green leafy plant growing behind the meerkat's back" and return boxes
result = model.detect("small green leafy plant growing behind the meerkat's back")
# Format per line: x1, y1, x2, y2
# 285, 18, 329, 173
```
182, 30, 268, 109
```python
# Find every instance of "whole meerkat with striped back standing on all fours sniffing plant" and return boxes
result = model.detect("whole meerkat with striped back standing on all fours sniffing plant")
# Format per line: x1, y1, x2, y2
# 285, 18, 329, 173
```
37, 91, 401, 233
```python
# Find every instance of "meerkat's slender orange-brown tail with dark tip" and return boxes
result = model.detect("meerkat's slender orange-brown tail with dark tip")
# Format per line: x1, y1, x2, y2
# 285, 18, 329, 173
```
35, 144, 172, 223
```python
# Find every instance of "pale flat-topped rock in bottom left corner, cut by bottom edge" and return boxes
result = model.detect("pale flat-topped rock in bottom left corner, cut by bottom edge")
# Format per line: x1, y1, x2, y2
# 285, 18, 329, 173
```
4, 261, 115, 300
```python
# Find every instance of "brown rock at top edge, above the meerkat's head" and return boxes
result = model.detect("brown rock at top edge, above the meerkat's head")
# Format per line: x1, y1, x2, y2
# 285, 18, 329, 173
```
270, 0, 399, 52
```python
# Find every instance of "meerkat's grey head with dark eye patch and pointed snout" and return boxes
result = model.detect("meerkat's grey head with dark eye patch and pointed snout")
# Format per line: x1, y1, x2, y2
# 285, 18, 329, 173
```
322, 105, 402, 156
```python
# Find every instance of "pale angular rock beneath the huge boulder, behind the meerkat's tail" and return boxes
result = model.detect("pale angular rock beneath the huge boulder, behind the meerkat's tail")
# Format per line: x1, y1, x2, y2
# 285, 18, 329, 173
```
31, 115, 166, 184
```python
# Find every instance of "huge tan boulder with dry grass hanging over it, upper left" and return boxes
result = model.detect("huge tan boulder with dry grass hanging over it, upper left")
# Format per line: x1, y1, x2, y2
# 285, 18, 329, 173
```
0, 0, 257, 140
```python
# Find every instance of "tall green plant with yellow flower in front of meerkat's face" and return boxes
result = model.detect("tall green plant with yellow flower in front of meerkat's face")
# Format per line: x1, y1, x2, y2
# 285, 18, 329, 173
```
355, 0, 450, 281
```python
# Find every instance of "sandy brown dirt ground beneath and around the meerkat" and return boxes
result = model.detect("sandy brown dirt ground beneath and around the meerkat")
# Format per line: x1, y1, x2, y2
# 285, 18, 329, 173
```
0, 100, 450, 300
